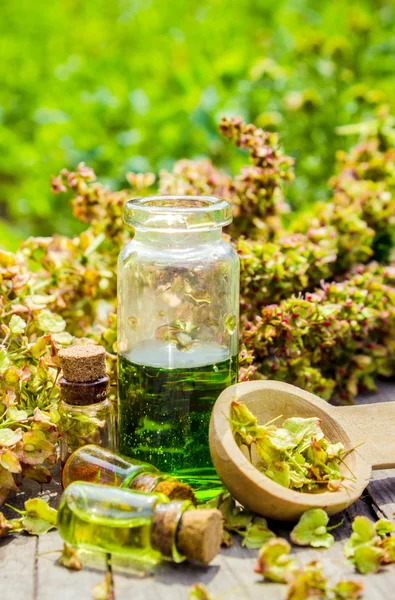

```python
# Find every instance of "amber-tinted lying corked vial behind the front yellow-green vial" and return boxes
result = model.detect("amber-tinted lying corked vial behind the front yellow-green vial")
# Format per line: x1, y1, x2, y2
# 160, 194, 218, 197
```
62, 444, 196, 504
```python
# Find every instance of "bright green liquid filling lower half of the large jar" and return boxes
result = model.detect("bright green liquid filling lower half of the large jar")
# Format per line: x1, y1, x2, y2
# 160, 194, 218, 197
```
119, 341, 238, 501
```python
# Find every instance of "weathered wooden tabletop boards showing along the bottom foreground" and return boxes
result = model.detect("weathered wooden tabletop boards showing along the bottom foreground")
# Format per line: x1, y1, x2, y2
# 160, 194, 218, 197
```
2, 486, 395, 600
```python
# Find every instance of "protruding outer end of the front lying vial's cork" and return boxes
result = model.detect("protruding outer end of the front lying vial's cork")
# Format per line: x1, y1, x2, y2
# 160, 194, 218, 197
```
176, 508, 223, 565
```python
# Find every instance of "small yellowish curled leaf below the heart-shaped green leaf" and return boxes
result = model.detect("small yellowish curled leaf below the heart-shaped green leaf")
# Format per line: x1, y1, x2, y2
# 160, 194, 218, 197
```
254, 538, 298, 583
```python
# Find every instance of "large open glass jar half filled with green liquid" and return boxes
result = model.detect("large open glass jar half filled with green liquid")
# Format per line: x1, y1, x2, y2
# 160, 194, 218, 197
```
118, 196, 239, 484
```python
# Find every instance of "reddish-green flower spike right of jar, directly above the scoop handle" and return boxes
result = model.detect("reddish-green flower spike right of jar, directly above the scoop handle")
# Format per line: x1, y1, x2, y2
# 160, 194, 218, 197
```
243, 264, 395, 402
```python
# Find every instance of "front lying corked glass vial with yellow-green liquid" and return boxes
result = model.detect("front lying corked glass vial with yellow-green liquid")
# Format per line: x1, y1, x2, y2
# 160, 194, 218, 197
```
58, 482, 222, 564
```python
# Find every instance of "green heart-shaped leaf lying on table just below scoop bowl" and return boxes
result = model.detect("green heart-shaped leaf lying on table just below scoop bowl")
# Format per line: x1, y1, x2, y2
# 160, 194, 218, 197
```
291, 508, 335, 548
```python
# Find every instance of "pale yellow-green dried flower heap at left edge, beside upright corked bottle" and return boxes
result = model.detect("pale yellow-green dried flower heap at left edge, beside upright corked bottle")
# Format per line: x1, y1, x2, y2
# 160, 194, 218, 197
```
0, 245, 64, 503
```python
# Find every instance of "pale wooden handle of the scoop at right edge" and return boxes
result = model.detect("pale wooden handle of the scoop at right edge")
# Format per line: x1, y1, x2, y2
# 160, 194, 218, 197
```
334, 402, 395, 469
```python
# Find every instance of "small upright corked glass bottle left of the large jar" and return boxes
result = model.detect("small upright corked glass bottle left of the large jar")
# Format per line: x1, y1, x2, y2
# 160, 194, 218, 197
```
59, 344, 116, 467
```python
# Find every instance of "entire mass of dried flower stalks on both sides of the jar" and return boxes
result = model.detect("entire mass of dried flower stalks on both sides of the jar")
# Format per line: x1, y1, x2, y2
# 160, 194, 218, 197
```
0, 111, 395, 501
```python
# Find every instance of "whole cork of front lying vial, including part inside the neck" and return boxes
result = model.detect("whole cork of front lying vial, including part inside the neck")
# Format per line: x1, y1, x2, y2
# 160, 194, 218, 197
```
151, 502, 223, 564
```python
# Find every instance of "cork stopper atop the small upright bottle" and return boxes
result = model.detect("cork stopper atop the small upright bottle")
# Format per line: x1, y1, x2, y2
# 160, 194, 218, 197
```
59, 344, 106, 383
